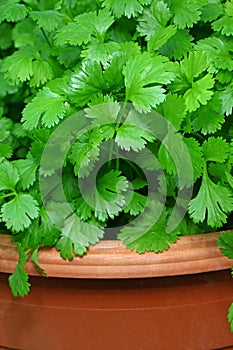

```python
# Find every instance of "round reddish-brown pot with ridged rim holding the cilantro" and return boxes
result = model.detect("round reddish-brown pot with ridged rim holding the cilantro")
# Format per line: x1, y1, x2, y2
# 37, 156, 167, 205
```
0, 233, 233, 350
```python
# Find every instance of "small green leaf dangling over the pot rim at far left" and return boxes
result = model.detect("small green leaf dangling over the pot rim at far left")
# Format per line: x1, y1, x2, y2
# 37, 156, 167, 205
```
9, 244, 31, 297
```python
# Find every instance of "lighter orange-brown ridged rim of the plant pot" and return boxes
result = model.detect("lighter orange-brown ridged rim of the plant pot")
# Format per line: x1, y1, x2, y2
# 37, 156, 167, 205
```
0, 232, 233, 278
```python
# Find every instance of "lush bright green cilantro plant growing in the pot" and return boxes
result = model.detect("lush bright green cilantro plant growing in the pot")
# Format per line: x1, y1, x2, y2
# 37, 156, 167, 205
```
0, 0, 233, 312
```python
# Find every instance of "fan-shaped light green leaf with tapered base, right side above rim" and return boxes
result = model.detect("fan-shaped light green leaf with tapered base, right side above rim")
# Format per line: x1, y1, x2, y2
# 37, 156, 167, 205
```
188, 170, 233, 227
